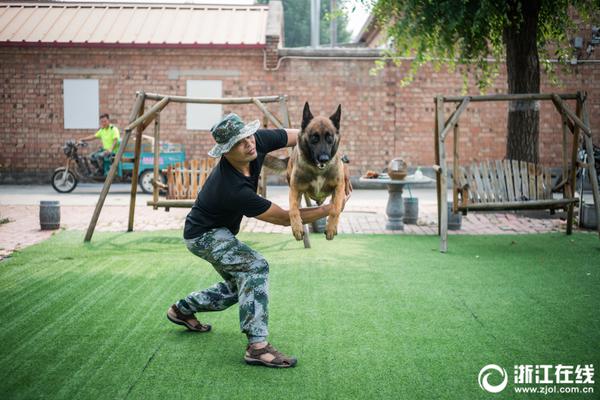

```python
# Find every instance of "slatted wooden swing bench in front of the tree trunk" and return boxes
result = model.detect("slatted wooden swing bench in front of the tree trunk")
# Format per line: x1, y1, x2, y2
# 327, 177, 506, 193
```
453, 160, 579, 214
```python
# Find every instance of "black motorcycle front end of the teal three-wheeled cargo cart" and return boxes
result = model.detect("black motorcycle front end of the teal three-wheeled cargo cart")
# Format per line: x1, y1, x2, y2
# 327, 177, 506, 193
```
51, 140, 114, 193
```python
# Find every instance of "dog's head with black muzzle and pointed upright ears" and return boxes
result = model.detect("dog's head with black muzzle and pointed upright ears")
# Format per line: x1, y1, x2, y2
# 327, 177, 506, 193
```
298, 102, 342, 169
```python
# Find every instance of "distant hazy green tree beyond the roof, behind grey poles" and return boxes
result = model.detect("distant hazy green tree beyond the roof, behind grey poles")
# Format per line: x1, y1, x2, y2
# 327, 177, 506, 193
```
258, 0, 350, 47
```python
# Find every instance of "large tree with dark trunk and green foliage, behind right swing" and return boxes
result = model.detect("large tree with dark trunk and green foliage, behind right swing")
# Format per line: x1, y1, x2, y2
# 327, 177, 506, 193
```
374, 0, 600, 162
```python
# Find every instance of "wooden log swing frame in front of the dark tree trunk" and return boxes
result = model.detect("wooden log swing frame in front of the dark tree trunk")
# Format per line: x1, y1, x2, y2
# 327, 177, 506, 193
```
434, 92, 600, 253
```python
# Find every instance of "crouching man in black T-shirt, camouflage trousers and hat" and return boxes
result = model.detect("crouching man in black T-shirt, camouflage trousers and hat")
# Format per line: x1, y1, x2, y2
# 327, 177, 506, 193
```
167, 114, 351, 368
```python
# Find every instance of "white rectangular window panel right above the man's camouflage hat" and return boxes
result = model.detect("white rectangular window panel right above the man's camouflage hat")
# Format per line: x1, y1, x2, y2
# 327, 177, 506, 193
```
186, 81, 223, 130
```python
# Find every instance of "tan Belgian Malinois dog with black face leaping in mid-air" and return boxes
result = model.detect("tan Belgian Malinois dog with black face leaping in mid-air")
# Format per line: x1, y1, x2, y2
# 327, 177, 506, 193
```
287, 102, 345, 240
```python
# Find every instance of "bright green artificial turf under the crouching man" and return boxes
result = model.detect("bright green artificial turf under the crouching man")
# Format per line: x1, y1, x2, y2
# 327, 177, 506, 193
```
0, 232, 600, 400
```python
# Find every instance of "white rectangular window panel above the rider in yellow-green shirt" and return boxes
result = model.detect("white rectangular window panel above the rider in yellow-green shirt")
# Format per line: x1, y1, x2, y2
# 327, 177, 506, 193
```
63, 79, 100, 129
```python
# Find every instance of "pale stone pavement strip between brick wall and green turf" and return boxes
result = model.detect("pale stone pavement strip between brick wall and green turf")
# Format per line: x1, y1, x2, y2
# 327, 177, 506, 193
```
0, 184, 584, 259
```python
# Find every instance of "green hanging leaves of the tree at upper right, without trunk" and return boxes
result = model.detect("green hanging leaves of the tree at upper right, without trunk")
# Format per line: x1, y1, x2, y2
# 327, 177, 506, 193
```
374, 0, 600, 90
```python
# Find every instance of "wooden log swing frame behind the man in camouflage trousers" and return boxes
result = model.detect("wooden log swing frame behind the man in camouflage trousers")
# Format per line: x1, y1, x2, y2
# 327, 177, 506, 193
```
84, 91, 310, 248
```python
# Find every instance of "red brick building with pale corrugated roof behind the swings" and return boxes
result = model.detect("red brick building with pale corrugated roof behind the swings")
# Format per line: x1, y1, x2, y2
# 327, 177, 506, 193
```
0, 0, 600, 183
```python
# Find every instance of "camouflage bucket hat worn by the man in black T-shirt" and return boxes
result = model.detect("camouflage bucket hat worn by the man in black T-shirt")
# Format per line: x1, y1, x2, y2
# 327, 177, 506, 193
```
208, 113, 260, 157
